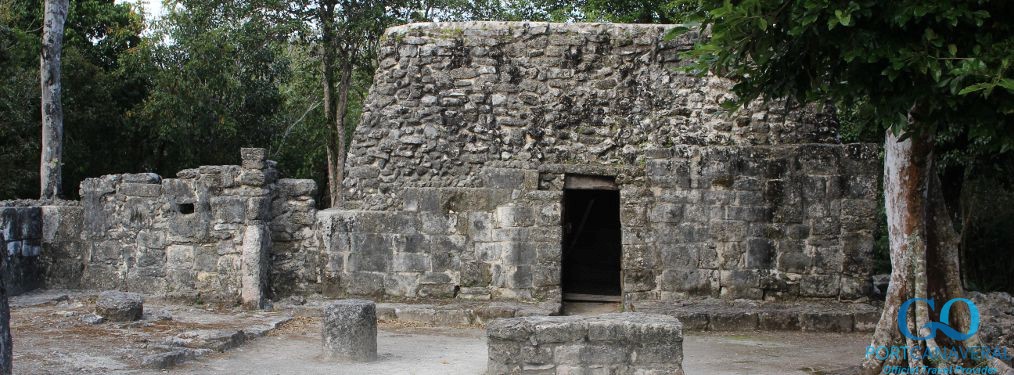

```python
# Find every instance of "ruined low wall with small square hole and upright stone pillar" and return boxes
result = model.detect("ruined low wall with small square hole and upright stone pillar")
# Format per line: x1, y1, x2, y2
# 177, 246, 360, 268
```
74, 149, 277, 305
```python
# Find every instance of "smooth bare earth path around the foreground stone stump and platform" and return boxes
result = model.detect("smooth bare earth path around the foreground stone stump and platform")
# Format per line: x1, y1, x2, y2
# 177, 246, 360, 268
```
159, 320, 869, 375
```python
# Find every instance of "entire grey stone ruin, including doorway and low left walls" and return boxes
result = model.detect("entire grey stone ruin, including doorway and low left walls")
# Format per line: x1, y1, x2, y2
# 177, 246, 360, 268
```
0, 22, 880, 311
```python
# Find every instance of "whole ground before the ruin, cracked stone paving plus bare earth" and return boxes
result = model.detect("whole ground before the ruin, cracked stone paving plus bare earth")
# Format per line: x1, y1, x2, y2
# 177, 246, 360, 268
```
11, 293, 869, 375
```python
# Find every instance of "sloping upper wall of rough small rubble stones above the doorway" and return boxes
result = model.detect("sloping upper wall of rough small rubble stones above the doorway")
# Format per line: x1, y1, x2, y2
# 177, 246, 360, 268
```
344, 22, 837, 210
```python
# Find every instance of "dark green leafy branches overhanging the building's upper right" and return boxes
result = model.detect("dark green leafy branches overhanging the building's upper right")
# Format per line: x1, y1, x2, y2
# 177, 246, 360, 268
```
680, 0, 1014, 152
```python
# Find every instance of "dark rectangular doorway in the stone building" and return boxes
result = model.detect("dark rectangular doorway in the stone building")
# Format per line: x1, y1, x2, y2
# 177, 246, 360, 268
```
562, 177, 623, 301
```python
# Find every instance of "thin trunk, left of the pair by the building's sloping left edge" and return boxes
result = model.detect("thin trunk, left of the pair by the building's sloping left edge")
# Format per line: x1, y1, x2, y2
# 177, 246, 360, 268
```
317, 0, 344, 207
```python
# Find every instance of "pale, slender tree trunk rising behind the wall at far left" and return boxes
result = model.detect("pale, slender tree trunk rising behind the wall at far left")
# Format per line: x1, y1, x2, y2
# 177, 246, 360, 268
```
39, 0, 69, 200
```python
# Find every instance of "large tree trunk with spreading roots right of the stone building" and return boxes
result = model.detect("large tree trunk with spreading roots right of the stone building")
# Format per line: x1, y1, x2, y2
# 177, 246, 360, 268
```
862, 121, 1014, 374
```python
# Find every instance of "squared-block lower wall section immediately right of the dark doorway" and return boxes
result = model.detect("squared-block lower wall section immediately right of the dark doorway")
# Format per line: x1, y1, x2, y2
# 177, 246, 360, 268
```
621, 144, 879, 300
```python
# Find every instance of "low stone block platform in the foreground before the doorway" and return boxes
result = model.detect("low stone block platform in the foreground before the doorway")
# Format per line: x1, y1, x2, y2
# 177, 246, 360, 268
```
486, 312, 683, 375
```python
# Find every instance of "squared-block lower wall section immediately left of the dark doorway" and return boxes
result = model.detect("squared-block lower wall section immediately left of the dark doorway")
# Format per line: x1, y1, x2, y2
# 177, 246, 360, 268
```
319, 177, 563, 301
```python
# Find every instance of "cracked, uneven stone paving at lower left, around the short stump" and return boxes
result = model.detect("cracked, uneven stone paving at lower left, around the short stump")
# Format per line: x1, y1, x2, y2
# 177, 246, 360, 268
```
11, 291, 291, 374
